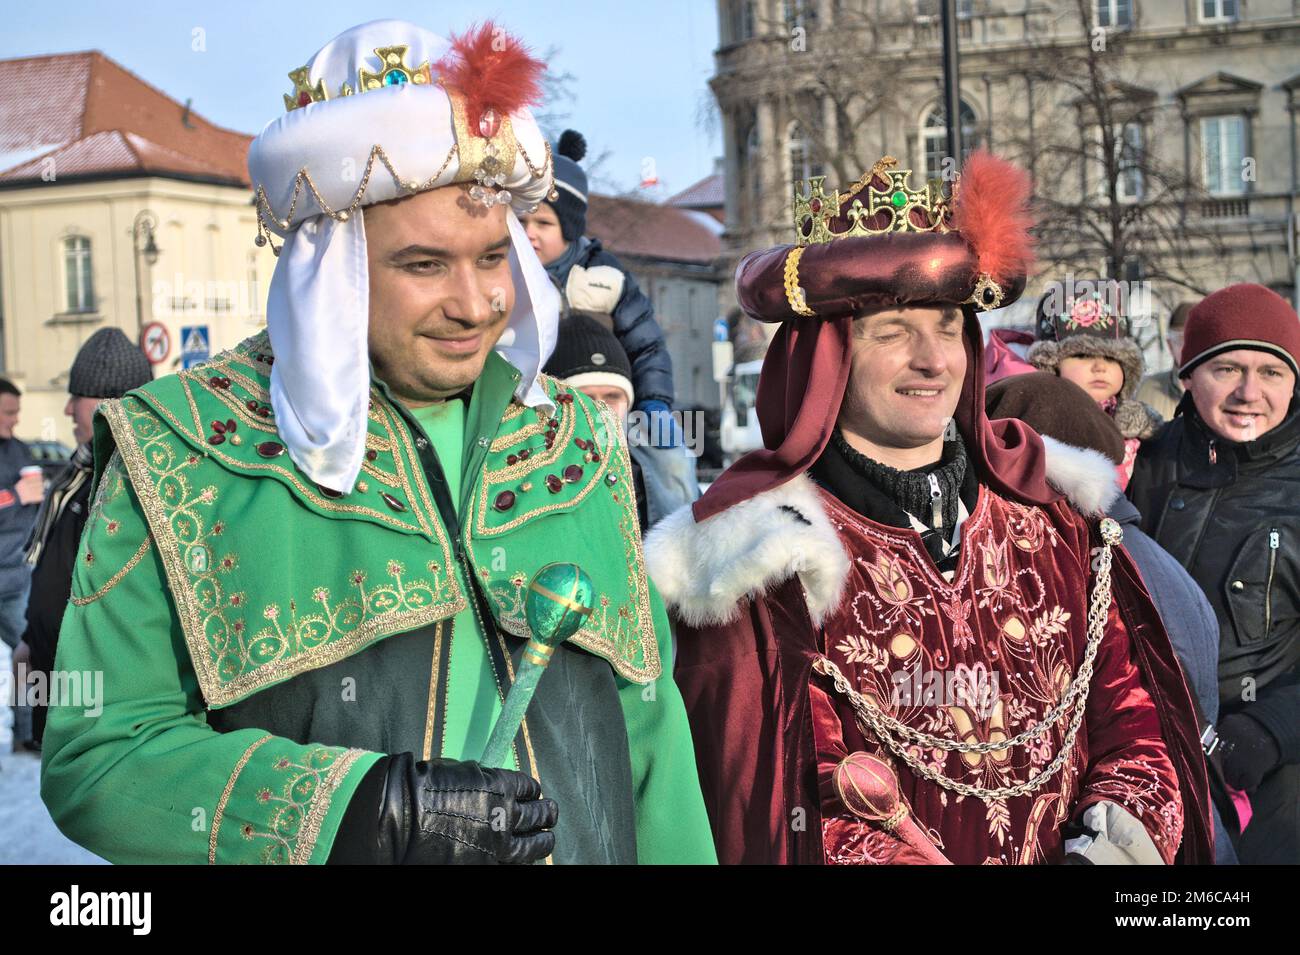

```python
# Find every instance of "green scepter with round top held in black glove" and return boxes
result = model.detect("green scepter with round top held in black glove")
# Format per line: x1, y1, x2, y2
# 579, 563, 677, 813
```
480, 564, 595, 768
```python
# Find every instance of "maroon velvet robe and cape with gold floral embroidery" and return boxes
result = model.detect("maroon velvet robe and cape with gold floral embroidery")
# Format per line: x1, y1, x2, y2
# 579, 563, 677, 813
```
676, 487, 1213, 864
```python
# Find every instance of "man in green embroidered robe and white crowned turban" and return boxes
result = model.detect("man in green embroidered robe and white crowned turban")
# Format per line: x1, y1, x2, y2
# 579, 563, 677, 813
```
42, 21, 715, 863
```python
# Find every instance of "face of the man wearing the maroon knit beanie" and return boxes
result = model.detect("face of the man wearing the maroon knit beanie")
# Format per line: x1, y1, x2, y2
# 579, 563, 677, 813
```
1187, 348, 1296, 440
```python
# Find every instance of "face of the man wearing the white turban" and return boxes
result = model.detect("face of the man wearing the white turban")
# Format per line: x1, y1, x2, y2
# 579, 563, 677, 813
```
365, 186, 515, 407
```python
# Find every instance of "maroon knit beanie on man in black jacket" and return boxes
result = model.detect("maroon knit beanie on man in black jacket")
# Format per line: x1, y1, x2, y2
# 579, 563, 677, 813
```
1178, 282, 1300, 378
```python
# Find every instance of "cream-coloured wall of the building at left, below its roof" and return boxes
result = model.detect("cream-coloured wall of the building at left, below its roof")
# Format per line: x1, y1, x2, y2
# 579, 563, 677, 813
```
0, 178, 274, 447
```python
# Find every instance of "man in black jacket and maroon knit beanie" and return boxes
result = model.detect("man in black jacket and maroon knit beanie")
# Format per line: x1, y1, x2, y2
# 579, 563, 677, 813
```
1128, 285, 1300, 863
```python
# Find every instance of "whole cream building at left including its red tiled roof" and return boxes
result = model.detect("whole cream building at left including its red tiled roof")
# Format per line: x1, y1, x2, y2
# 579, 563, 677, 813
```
0, 51, 263, 448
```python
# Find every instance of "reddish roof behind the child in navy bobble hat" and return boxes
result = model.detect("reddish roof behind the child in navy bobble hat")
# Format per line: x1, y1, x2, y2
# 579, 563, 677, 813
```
586, 194, 723, 265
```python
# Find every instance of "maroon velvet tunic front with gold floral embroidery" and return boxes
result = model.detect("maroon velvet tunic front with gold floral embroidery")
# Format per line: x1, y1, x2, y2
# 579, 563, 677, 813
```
823, 489, 1182, 863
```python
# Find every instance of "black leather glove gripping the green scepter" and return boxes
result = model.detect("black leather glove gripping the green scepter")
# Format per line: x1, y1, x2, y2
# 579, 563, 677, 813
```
329, 752, 559, 865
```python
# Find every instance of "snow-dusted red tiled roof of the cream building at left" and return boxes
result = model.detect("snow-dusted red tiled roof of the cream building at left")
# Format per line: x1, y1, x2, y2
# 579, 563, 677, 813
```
0, 51, 252, 186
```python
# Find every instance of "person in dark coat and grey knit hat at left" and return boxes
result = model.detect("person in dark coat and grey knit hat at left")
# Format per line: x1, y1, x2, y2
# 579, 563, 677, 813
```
20, 329, 153, 746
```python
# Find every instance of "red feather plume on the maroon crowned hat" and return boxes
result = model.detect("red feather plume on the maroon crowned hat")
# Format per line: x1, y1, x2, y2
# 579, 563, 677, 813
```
953, 149, 1034, 282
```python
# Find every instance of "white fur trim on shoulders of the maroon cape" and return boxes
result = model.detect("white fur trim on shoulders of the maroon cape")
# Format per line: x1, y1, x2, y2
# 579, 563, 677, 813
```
645, 437, 1119, 626
